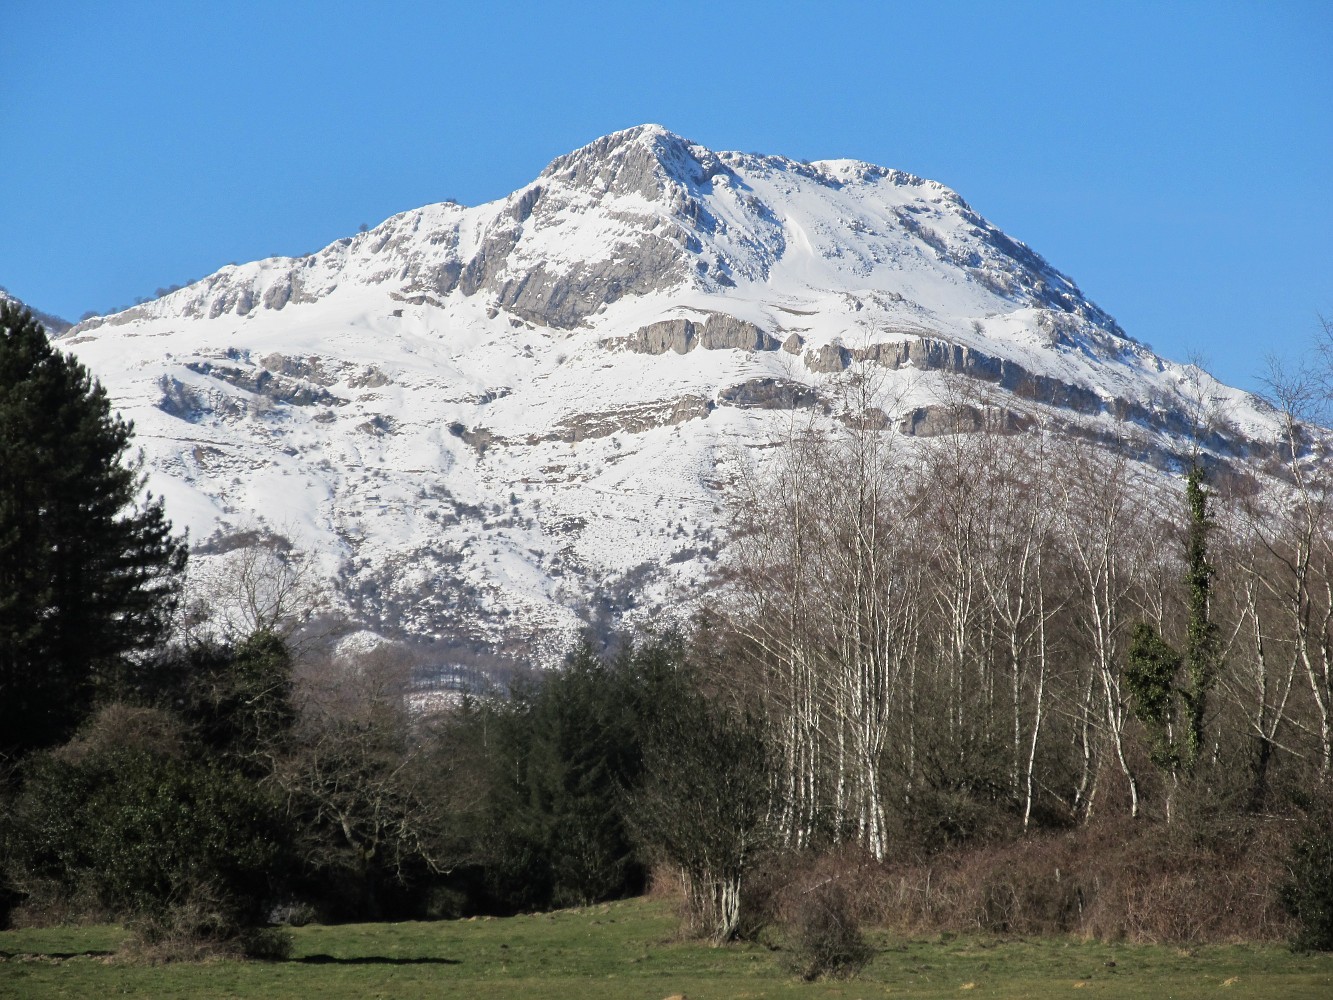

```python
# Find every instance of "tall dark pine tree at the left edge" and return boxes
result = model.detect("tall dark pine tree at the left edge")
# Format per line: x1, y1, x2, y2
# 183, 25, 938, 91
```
0, 303, 187, 753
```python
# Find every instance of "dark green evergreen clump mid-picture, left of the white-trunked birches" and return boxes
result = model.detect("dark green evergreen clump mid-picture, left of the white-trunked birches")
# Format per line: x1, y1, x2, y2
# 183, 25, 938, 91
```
469, 635, 693, 911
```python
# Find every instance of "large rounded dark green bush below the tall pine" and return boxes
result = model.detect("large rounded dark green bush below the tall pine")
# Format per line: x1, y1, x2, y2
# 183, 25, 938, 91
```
12, 708, 287, 957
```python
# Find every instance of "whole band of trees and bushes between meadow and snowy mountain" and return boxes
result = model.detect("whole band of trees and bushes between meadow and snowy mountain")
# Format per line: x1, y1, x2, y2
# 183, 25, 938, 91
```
0, 305, 1333, 975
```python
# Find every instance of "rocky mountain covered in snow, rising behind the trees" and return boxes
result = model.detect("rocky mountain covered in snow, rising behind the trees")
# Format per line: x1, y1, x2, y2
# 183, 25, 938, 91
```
49, 125, 1274, 666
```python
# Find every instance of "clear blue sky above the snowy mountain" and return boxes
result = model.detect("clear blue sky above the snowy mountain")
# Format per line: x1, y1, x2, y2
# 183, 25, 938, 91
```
0, 0, 1333, 387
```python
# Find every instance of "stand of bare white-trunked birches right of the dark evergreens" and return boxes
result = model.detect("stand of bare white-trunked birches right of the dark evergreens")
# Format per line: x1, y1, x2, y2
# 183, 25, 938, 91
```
721, 392, 1333, 856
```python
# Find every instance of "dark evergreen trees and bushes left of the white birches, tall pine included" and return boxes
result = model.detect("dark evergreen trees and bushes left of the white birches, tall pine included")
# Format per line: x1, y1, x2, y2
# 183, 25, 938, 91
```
0, 305, 765, 956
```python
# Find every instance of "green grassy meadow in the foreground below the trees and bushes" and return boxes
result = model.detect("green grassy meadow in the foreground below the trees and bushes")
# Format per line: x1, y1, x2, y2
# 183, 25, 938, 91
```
0, 900, 1333, 1000
